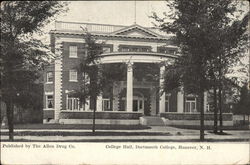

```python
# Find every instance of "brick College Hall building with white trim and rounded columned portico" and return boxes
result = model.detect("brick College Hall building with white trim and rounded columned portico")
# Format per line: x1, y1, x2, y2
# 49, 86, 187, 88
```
43, 22, 232, 125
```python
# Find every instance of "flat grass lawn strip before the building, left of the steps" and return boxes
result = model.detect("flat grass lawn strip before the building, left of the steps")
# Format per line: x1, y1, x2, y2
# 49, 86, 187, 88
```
1, 124, 151, 130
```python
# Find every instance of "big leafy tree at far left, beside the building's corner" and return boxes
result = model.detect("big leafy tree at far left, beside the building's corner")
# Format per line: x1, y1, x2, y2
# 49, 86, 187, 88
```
0, 1, 66, 140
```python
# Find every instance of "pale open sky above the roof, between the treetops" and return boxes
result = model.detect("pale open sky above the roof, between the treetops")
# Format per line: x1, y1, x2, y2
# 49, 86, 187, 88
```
39, 1, 167, 44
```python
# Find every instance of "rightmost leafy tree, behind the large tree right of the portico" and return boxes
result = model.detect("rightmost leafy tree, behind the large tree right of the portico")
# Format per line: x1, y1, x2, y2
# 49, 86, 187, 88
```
208, 8, 249, 133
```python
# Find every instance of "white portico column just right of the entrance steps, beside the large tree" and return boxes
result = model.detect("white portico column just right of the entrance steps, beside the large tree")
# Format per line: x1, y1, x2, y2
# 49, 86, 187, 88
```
159, 66, 166, 113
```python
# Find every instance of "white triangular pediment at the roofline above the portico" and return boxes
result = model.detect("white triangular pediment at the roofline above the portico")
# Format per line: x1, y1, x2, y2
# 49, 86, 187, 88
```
111, 24, 159, 37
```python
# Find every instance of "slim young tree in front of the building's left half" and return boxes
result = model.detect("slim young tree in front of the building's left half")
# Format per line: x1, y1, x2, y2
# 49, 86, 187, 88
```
72, 29, 104, 133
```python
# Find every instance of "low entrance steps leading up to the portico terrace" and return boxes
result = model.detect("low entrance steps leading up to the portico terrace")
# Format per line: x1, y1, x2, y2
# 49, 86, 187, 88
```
140, 116, 165, 126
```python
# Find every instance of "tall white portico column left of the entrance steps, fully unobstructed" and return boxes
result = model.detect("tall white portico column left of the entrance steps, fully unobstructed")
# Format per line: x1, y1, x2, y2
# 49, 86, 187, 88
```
126, 62, 133, 112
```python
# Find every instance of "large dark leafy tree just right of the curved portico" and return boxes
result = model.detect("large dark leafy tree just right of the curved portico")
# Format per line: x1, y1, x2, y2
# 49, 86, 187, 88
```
153, 0, 248, 140
